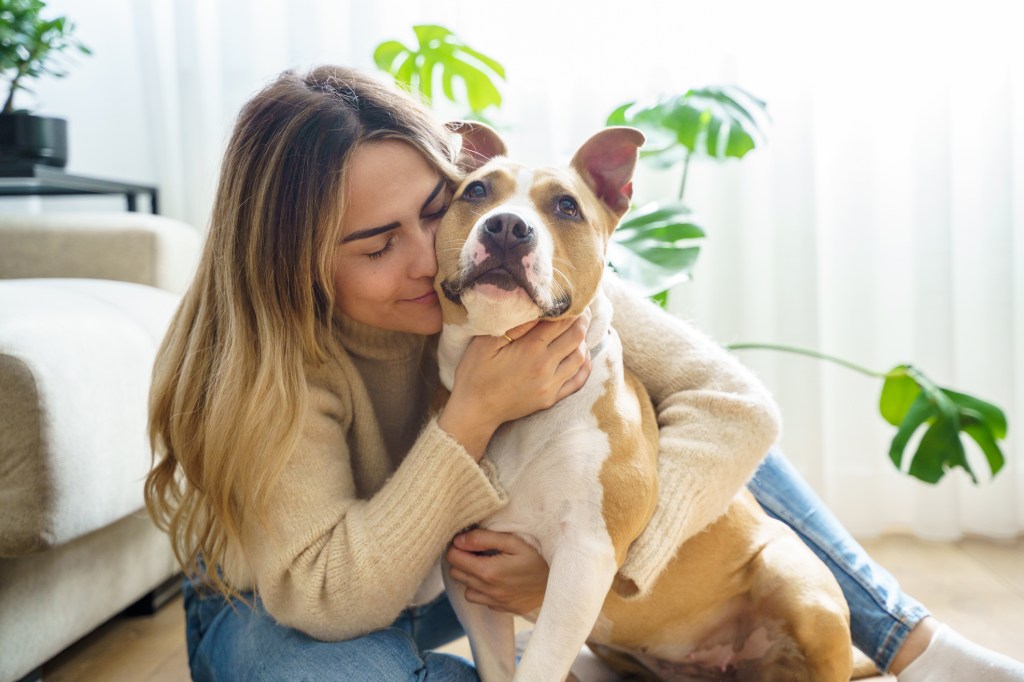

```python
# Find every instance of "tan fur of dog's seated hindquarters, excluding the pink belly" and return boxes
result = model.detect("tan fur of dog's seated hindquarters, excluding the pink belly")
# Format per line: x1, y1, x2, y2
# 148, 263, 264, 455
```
591, 491, 852, 682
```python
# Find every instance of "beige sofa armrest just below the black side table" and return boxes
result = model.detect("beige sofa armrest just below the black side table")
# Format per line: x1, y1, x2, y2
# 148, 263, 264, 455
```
0, 213, 201, 293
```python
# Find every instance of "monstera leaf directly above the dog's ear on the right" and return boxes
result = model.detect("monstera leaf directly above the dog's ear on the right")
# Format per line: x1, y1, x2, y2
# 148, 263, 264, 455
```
607, 85, 768, 168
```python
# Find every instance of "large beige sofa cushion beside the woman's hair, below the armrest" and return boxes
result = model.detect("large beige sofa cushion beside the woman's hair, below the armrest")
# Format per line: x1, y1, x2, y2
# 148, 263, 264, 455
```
0, 279, 178, 556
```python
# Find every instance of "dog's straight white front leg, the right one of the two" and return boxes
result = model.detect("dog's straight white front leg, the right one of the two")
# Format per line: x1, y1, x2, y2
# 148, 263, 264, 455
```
515, 537, 617, 682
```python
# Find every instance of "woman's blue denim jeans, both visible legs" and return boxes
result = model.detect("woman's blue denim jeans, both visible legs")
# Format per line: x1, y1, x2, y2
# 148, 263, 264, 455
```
184, 451, 928, 682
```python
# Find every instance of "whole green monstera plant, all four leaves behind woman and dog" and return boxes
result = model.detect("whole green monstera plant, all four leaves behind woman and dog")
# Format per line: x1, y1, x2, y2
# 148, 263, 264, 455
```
374, 26, 1007, 483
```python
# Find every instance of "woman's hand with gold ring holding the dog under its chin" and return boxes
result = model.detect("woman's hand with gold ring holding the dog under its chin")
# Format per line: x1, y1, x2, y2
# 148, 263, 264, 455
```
438, 310, 591, 460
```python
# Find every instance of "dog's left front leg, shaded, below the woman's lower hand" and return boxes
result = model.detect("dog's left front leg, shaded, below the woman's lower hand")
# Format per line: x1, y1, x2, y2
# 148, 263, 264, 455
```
441, 548, 515, 682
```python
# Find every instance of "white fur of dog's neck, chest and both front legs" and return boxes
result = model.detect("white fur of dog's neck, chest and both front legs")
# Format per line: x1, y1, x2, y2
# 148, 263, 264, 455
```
438, 284, 641, 682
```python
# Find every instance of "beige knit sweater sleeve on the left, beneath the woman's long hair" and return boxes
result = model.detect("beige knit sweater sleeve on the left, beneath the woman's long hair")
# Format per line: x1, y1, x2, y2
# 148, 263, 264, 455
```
232, 366, 506, 640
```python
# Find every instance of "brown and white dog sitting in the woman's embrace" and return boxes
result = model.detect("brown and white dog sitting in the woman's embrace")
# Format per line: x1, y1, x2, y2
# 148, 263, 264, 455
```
436, 124, 851, 682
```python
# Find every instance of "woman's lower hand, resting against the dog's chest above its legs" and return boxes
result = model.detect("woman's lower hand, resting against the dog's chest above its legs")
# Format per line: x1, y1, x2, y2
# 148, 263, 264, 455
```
447, 528, 548, 615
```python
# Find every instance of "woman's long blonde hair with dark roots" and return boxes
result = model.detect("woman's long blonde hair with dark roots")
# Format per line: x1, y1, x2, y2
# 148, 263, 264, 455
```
145, 67, 457, 595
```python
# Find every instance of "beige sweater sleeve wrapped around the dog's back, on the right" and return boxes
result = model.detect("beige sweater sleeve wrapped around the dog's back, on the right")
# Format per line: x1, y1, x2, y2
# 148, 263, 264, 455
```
605, 276, 779, 596
